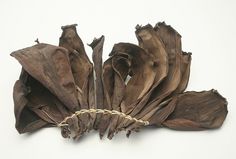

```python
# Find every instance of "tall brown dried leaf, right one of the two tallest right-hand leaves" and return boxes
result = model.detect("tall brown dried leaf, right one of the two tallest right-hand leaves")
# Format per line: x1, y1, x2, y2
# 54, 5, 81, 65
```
133, 23, 182, 119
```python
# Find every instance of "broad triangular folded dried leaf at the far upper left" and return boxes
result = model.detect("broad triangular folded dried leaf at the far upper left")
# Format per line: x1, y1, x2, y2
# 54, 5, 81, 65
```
11, 44, 78, 110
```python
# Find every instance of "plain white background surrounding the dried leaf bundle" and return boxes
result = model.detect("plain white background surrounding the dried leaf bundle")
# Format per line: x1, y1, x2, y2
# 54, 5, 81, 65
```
0, 0, 236, 159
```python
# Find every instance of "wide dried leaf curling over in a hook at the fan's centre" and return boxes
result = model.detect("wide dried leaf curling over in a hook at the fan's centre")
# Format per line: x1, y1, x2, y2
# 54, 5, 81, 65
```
110, 43, 157, 113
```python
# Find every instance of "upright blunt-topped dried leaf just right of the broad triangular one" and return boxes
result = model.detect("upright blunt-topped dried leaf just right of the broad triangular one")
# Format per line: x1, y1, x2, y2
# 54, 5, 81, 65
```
59, 24, 93, 109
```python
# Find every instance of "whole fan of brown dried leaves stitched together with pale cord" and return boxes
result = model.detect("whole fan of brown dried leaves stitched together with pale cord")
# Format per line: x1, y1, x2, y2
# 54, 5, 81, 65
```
11, 22, 227, 139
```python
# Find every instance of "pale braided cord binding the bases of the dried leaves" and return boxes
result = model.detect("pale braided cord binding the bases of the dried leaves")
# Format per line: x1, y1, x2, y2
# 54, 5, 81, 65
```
57, 109, 149, 127
